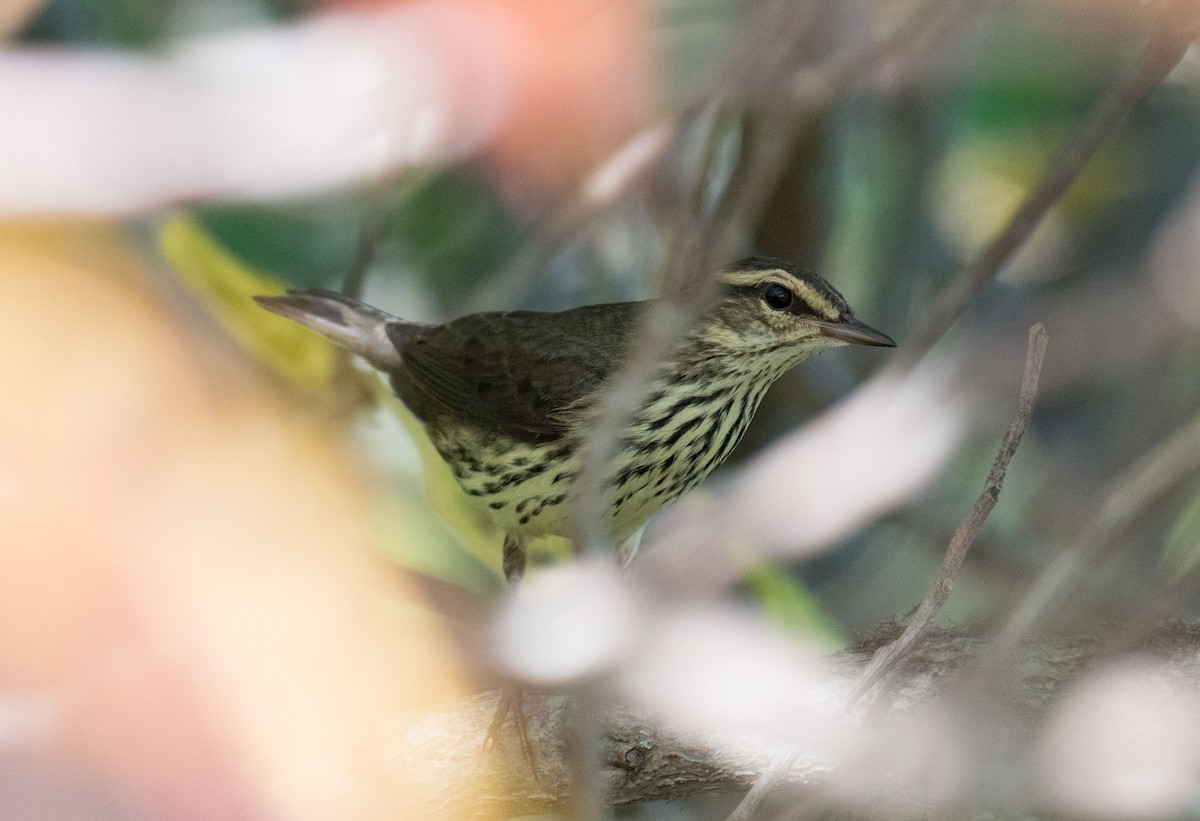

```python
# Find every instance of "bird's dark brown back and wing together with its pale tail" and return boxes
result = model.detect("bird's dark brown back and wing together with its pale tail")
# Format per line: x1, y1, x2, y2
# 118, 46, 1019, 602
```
256, 289, 640, 444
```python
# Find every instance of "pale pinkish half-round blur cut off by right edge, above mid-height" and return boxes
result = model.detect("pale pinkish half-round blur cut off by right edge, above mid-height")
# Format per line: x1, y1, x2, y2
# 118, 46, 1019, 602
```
1150, 172, 1200, 330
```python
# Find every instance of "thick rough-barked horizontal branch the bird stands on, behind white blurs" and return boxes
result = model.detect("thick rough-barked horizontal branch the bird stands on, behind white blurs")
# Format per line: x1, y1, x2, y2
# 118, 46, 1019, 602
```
391, 623, 1200, 819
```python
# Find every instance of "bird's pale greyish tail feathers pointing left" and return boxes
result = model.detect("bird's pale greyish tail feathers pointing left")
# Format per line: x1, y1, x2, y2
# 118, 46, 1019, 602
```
254, 288, 416, 371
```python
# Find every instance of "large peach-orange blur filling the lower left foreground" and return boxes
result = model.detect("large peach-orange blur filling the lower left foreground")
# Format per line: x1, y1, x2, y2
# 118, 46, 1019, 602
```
0, 224, 482, 820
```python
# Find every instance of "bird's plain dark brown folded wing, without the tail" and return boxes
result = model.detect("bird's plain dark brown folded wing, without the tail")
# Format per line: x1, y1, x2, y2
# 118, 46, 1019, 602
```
391, 302, 638, 442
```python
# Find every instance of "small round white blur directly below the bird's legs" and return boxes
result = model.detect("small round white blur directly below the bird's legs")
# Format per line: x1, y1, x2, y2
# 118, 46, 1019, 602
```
496, 561, 638, 685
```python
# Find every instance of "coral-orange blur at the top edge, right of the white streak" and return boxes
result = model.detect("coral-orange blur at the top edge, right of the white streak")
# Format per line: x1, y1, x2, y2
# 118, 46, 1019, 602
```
336, 0, 659, 199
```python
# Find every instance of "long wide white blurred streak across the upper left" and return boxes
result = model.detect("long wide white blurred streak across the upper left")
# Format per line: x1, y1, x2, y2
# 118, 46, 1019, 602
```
0, 4, 509, 214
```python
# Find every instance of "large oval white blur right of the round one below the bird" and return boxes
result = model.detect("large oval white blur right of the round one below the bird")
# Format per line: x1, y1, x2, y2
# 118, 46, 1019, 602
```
620, 607, 862, 759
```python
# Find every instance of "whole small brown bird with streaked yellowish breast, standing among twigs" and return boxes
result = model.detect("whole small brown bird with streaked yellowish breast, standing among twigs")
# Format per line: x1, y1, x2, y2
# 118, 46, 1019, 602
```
256, 258, 895, 588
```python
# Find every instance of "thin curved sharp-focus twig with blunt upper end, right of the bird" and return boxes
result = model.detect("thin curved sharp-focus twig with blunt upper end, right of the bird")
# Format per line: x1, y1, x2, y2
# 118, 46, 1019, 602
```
848, 323, 1049, 706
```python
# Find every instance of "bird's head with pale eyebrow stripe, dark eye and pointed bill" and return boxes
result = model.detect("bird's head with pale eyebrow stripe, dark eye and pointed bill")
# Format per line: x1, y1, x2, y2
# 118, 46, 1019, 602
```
700, 257, 895, 364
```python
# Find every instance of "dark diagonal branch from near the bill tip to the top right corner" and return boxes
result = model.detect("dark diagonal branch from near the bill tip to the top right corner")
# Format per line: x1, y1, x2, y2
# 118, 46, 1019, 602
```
894, 0, 1200, 367
